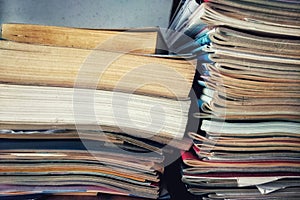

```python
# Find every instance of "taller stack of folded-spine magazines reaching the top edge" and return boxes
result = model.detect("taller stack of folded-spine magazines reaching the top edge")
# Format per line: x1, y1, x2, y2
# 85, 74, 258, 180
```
169, 0, 300, 200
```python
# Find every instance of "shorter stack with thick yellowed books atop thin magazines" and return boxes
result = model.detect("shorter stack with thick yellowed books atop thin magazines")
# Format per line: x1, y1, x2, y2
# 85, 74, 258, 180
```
0, 24, 195, 198
